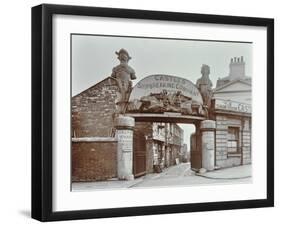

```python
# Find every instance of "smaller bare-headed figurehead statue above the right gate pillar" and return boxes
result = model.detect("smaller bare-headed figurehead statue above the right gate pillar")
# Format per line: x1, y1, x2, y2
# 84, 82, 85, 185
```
196, 64, 213, 109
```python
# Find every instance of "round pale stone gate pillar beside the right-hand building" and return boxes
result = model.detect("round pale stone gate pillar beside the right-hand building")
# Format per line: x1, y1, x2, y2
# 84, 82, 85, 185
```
200, 120, 216, 171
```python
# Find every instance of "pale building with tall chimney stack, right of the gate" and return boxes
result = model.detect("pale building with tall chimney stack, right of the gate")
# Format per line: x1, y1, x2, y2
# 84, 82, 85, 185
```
212, 57, 249, 167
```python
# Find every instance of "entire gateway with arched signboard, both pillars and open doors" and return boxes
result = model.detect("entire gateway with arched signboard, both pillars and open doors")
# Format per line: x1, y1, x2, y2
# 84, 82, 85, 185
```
116, 75, 215, 179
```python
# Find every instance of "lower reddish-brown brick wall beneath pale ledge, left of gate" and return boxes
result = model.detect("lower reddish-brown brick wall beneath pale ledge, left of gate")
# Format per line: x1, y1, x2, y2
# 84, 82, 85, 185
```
72, 142, 117, 182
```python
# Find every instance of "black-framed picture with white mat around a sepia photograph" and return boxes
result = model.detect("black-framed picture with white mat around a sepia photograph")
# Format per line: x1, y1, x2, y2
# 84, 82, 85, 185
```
31, 4, 274, 221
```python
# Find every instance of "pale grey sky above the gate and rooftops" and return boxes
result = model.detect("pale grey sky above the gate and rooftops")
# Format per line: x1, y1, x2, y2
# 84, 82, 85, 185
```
71, 34, 252, 145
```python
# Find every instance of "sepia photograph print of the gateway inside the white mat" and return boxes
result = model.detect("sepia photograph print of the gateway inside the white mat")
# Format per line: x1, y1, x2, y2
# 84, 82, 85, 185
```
70, 33, 253, 192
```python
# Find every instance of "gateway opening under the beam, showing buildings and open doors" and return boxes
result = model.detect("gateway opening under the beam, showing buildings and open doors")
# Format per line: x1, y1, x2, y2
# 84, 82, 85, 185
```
130, 116, 202, 177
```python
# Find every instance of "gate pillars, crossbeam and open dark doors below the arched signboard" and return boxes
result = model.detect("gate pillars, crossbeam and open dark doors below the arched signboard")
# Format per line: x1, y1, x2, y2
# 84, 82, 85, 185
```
116, 114, 215, 179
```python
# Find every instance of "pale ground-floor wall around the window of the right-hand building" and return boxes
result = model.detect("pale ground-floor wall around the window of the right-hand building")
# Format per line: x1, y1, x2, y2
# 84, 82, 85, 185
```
215, 115, 251, 167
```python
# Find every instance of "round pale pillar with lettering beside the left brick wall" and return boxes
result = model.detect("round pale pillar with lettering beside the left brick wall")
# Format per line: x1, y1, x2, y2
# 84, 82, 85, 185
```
115, 115, 135, 180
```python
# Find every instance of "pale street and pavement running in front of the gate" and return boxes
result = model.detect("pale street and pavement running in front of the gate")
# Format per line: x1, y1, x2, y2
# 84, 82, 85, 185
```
72, 163, 252, 191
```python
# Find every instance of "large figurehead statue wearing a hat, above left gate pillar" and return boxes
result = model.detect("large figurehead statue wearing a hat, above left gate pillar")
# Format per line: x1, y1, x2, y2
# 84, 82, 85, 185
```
111, 48, 136, 113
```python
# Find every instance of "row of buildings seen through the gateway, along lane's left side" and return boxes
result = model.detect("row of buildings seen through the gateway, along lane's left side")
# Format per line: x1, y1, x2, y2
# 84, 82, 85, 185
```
134, 122, 184, 176
